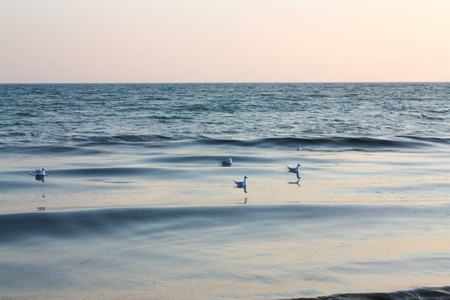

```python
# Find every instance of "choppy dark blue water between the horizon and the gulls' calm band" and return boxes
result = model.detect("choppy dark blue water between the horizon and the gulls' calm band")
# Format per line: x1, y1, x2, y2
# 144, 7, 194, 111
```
0, 83, 450, 156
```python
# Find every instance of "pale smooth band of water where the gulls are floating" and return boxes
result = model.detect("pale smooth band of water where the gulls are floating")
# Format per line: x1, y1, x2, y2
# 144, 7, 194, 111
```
0, 145, 450, 213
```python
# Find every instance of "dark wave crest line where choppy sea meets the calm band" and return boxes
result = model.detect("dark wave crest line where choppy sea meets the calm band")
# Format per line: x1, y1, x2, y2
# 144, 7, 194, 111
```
0, 132, 450, 155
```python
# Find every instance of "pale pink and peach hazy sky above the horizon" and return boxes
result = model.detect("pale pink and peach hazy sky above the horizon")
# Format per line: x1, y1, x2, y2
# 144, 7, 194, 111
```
0, 0, 450, 83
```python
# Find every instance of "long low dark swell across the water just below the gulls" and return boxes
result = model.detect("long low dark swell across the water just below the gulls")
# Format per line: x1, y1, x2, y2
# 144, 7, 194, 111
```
0, 204, 448, 243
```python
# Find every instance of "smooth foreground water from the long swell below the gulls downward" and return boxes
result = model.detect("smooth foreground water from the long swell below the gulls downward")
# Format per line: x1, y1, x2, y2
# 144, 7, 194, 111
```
0, 204, 450, 299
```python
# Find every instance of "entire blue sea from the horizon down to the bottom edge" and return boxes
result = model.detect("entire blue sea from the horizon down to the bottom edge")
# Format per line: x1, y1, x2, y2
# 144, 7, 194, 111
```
0, 83, 450, 299
